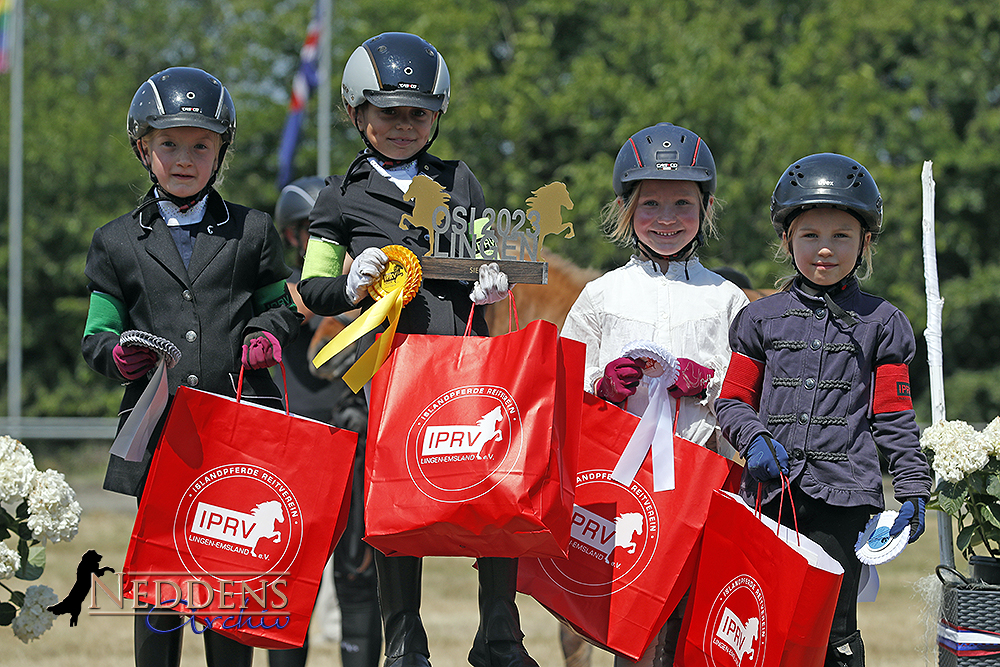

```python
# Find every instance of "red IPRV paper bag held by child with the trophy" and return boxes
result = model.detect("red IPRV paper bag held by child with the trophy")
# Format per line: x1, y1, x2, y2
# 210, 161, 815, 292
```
365, 320, 585, 558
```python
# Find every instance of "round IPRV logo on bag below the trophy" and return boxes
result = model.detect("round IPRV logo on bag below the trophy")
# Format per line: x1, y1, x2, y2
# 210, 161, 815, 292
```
406, 385, 523, 503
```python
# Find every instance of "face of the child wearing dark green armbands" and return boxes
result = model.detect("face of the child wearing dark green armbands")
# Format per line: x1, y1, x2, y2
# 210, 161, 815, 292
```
141, 127, 221, 197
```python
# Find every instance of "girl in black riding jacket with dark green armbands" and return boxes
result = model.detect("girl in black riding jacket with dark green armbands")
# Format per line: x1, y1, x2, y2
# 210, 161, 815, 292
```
82, 67, 299, 667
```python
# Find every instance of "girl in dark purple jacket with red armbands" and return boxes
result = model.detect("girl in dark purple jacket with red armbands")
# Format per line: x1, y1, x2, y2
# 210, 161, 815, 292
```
715, 153, 931, 667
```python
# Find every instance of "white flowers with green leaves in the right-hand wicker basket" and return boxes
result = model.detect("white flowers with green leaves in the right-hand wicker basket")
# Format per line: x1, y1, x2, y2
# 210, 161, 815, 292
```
920, 417, 1000, 559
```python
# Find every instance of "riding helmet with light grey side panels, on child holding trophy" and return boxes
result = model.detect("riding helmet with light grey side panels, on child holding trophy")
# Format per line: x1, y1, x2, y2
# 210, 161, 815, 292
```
341, 32, 451, 172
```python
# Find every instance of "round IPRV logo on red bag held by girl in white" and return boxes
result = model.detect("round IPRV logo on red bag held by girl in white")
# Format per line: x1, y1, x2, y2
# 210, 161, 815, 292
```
539, 470, 660, 598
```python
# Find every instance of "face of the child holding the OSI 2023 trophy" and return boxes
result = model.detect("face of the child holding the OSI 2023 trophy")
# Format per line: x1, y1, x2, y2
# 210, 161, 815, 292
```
347, 104, 438, 160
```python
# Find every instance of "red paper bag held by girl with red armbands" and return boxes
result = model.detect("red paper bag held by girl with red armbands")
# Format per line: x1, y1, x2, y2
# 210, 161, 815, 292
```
678, 492, 844, 667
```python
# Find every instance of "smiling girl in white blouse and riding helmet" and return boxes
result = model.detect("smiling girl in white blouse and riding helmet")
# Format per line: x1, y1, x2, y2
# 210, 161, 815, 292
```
562, 123, 748, 665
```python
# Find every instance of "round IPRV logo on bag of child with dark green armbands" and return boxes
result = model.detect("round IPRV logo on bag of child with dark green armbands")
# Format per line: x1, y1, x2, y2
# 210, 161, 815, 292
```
174, 464, 303, 581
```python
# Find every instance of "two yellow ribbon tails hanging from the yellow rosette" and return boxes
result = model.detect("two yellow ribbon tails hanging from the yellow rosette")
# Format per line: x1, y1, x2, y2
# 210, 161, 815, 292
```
313, 284, 404, 394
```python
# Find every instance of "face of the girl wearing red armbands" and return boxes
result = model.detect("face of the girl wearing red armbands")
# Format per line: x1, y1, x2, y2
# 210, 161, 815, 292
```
785, 208, 872, 285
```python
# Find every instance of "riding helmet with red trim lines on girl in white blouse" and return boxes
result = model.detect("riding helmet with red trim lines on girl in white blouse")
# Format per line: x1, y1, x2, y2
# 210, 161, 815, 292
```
612, 123, 717, 260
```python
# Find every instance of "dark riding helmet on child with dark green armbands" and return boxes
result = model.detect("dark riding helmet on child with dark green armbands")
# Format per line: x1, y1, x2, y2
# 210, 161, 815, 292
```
126, 67, 236, 210
